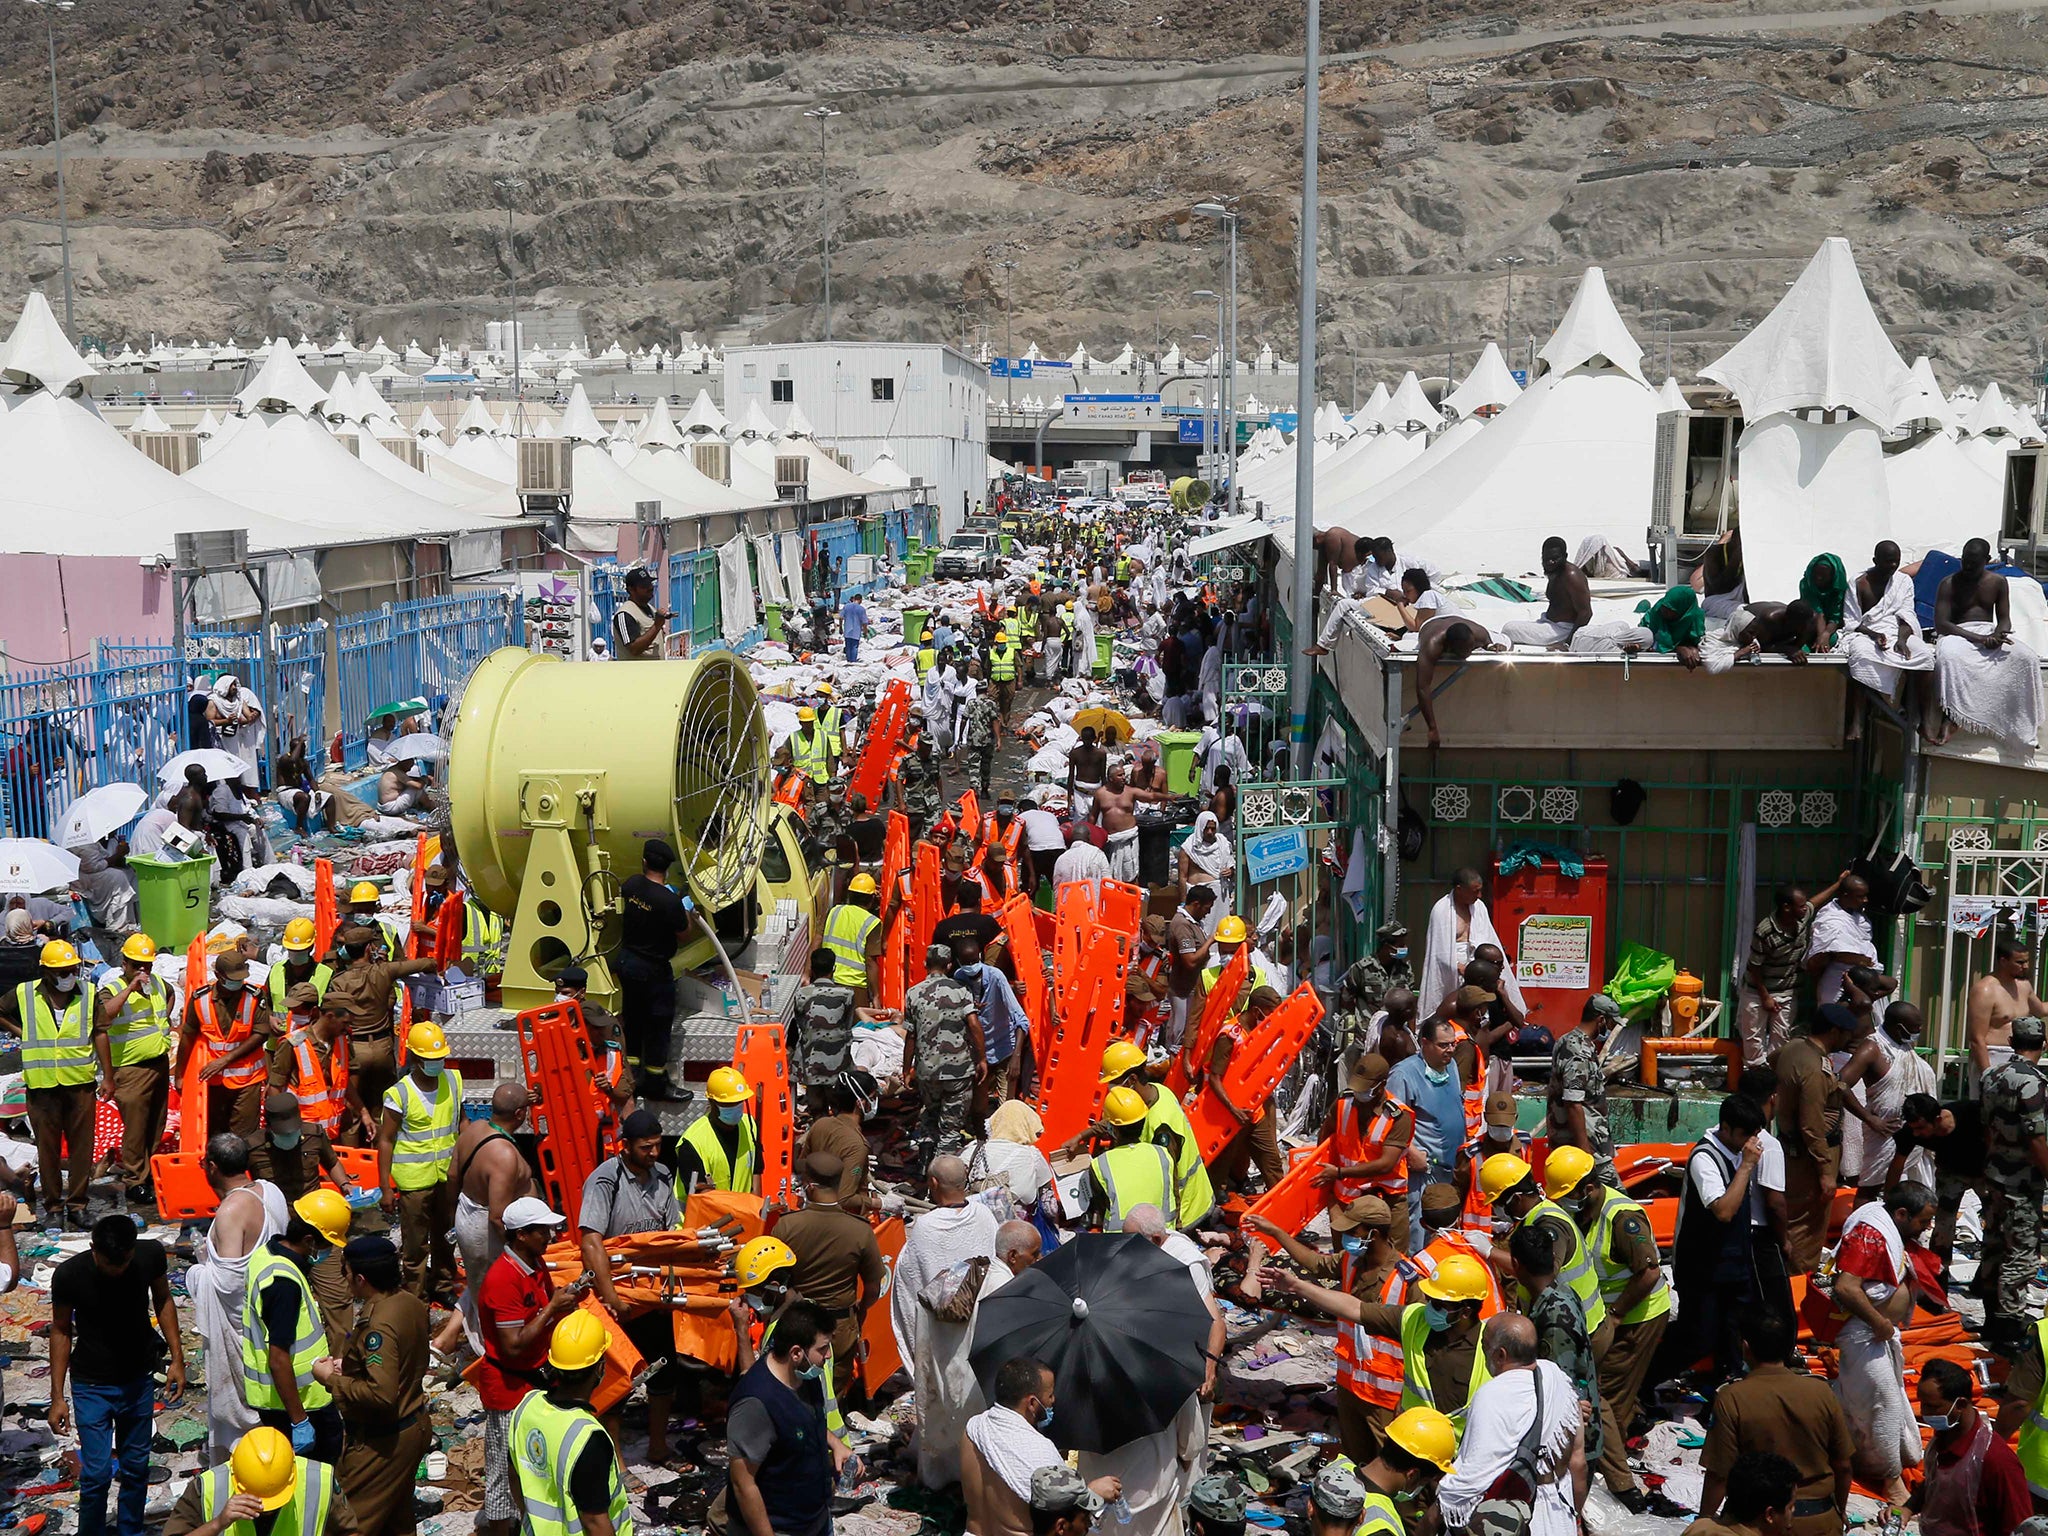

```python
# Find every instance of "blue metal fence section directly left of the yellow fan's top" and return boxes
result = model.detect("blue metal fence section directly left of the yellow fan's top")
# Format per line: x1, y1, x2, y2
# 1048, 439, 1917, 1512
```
334, 592, 520, 768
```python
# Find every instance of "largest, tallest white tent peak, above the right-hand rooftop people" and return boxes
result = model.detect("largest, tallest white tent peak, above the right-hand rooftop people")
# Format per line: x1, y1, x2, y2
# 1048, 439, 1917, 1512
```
1700, 236, 1911, 432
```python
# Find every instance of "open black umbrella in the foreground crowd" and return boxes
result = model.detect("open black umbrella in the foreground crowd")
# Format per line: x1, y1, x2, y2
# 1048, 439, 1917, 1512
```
969, 1233, 1210, 1452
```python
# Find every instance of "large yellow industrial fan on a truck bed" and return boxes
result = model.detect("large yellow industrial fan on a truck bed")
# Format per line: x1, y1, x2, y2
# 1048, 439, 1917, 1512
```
449, 647, 772, 1008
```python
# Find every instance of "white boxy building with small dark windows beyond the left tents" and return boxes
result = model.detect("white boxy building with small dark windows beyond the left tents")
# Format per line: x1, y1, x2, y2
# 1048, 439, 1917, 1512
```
725, 342, 989, 537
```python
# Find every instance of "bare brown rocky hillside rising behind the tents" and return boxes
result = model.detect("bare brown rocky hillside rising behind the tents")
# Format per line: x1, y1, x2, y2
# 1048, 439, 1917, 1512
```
0, 0, 2048, 399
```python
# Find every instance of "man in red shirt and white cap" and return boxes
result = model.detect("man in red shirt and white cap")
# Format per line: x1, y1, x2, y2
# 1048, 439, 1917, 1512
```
477, 1194, 590, 1536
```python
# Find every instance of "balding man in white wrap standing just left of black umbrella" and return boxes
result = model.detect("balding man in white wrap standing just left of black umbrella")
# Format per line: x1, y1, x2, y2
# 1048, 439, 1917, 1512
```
889, 1157, 1010, 1489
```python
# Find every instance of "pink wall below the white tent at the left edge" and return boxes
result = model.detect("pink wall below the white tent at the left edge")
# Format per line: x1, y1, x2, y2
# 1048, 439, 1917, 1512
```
0, 555, 172, 666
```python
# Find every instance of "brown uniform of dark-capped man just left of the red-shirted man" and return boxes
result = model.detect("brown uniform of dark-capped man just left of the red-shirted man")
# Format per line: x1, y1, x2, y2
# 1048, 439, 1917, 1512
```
334, 1290, 434, 1536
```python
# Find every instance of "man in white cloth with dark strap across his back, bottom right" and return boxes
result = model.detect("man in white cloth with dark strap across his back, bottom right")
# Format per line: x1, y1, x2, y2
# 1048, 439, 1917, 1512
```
1436, 1313, 1587, 1536
